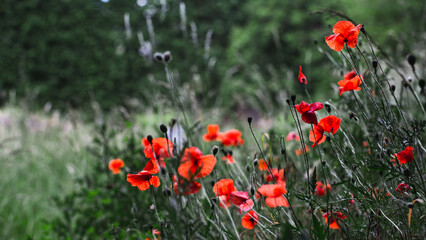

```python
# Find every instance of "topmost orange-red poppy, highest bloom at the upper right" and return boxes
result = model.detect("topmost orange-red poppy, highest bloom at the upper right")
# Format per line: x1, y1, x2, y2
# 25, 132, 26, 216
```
325, 21, 361, 52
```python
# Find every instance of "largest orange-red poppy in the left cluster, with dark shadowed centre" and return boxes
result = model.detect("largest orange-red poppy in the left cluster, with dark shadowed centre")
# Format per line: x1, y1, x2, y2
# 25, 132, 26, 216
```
178, 147, 216, 180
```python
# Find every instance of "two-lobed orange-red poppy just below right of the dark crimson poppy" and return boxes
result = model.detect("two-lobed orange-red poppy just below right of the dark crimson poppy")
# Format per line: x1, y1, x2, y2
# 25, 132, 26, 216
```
309, 115, 341, 147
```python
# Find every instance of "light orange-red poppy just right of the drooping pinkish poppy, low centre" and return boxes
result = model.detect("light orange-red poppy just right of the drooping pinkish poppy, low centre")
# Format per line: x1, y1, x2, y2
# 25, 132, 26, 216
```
257, 182, 290, 208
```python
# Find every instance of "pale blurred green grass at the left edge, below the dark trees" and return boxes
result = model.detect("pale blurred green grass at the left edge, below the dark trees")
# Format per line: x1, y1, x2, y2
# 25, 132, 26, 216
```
0, 107, 94, 239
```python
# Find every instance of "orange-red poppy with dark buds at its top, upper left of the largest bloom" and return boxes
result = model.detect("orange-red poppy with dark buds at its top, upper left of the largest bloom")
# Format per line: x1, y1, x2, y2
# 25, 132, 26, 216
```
142, 138, 173, 167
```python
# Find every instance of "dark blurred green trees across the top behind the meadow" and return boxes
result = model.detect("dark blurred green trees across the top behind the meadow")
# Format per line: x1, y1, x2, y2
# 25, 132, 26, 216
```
0, 0, 426, 111
